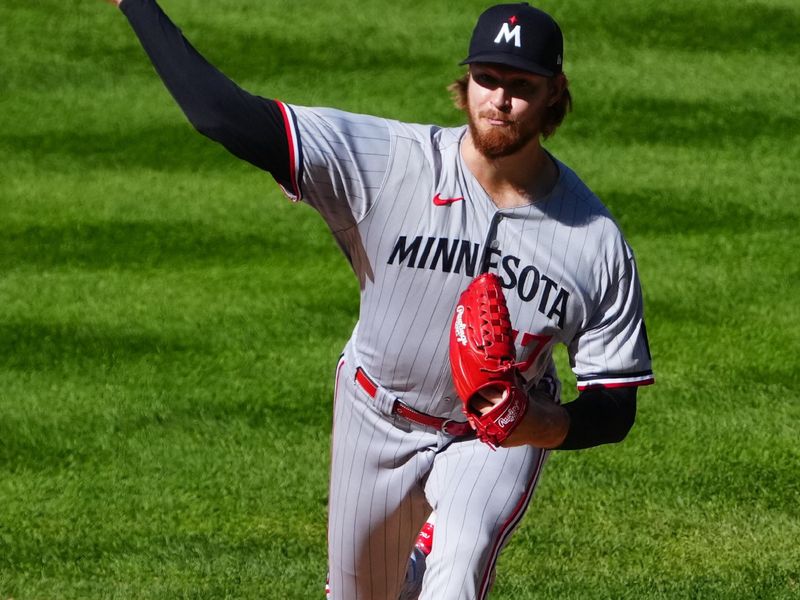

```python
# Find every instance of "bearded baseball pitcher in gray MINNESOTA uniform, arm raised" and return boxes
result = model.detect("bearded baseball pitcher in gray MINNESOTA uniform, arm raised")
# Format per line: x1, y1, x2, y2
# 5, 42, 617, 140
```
106, 0, 653, 600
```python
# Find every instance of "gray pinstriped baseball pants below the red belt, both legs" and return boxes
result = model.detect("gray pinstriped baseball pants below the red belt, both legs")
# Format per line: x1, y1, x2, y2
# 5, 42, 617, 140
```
328, 349, 549, 600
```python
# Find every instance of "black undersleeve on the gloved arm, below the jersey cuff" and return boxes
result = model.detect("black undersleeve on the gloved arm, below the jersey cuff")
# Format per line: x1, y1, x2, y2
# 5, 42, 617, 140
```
558, 387, 637, 450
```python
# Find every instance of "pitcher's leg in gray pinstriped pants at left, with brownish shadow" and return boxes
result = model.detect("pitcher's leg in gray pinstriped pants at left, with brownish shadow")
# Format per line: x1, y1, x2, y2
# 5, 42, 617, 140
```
328, 364, 438, 600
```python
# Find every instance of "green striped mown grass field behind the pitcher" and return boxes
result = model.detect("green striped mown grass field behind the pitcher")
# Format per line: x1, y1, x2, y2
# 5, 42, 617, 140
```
0, 0, 800, 600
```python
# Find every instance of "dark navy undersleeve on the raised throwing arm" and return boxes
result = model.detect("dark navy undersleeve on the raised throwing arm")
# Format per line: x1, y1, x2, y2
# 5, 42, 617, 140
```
120, 0, 291, 187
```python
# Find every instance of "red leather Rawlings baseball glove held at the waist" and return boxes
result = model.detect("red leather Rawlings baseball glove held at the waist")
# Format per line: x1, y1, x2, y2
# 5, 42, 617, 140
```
450, 273, 528, 448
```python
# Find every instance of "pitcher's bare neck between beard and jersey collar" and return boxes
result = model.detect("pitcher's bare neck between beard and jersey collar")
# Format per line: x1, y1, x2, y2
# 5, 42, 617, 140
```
461, 132, 558, 208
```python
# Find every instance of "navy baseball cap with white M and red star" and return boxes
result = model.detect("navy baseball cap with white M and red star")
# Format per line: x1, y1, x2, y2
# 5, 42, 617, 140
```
460, 2, 564, 77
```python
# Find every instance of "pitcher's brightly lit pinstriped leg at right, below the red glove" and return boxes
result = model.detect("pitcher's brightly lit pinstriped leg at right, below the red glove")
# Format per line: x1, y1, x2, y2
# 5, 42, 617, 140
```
420, 439, 548, 600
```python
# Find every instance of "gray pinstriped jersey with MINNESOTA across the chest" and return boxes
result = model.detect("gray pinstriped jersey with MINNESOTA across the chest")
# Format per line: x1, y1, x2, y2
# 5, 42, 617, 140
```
282, 105, 653, 417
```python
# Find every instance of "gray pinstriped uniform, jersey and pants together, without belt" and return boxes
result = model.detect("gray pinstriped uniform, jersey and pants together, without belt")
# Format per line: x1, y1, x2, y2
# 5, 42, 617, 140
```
285, 105, 652, 600
